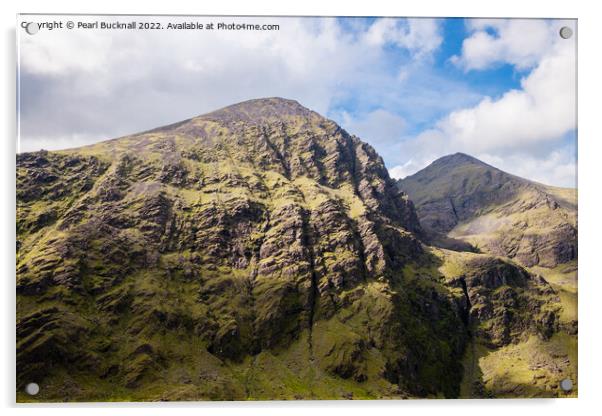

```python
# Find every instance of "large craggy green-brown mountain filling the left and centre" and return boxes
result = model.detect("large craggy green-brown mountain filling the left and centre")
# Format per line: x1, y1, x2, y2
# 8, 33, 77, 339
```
17, 98, 466, 400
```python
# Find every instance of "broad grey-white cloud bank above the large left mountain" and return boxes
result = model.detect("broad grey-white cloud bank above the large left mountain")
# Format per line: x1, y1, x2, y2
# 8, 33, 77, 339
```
19, 16, 441, 151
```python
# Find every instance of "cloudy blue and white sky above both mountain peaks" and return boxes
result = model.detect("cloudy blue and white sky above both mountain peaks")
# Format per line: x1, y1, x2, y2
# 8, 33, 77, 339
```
18, 16, 577, 187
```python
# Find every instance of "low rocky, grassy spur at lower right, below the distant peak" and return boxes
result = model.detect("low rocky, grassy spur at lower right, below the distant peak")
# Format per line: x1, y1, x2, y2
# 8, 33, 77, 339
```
431, 248, 577, 398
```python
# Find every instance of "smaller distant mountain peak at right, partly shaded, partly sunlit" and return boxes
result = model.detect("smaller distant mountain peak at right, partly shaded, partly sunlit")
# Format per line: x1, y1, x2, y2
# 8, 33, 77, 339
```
398, 153, 577, 267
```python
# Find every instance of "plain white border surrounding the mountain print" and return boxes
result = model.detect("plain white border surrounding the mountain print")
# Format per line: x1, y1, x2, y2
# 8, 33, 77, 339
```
0, 0, 602, 416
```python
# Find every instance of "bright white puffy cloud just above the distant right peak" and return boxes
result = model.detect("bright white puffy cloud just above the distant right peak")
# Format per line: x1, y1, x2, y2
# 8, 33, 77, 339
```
437, 37, 576, 151
